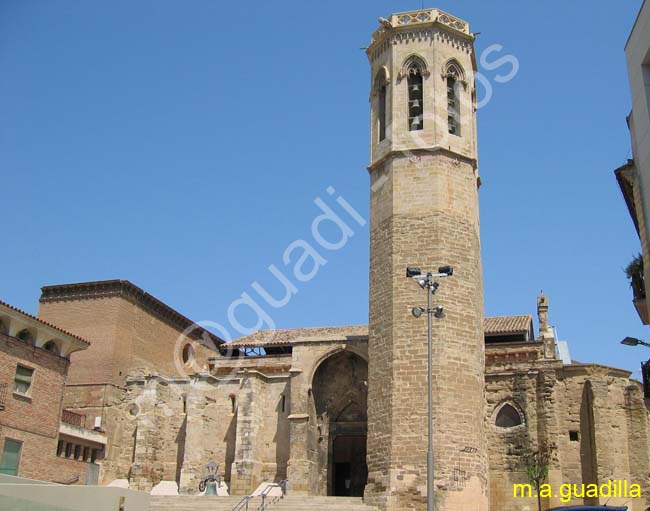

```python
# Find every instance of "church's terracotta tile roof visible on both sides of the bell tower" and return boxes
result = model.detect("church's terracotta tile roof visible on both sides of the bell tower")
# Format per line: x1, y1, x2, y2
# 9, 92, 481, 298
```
228, 314, 533, 348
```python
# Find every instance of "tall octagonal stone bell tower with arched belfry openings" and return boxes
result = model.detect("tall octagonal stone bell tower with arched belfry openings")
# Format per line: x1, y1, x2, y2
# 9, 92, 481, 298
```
365, 9, 488, 511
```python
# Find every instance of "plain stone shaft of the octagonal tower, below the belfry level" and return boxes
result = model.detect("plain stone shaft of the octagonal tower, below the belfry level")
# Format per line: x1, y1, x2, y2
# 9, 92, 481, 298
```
366, 153, 487, 510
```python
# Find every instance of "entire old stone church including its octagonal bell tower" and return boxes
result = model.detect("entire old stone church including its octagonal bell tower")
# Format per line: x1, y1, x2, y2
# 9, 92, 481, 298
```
31, 9, 650, 511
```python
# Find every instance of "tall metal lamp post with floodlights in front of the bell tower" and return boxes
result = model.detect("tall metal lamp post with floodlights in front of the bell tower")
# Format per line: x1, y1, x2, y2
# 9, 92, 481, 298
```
406, 266, 454, 511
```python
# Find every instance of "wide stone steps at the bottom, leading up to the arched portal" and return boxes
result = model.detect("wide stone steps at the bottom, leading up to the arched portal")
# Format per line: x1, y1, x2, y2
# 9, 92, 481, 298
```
149, 495, 377, 511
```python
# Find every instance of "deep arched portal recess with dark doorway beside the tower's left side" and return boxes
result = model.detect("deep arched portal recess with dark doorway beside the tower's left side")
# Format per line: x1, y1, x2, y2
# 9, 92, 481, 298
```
312, 350, 368, 497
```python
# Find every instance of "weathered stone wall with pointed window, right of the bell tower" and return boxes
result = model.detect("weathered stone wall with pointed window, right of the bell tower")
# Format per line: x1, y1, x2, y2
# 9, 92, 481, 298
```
486, 362, 650, 511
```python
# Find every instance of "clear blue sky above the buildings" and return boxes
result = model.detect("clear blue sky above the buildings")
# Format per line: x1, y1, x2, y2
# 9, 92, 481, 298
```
0, 0, 648, 370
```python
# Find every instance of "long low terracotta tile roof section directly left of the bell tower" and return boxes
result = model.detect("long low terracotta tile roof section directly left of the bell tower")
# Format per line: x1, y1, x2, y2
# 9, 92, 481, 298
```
228, 325, 368, 348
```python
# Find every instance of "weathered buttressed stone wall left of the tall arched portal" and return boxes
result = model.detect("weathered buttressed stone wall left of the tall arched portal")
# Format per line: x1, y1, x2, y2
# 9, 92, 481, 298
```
108, 362, 290, 494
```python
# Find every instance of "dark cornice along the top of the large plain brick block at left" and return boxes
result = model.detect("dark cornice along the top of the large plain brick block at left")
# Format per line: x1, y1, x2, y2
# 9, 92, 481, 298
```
39, 280, 224, 345
